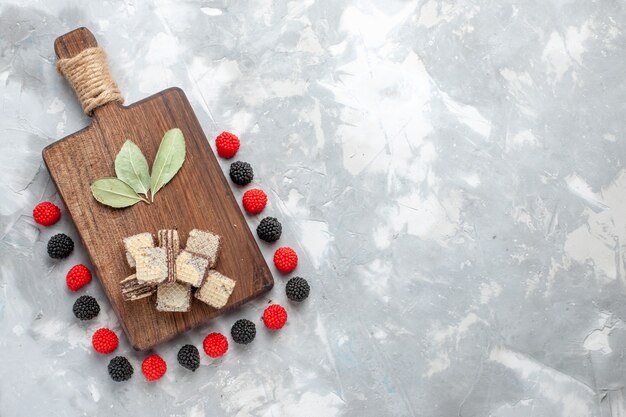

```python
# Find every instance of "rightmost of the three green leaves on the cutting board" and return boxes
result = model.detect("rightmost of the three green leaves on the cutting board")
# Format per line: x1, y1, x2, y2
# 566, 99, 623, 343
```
150, 128, 185, 201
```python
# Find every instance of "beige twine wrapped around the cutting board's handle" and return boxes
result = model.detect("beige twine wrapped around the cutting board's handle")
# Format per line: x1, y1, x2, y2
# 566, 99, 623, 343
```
57, 47, 124, 116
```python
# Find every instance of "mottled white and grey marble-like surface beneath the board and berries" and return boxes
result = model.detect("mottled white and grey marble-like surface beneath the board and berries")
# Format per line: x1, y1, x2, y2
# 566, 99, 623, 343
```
0, 0, 626, 417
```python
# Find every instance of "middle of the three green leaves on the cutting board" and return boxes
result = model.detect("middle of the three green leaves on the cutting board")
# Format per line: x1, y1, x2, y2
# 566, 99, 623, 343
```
115, 140, 150, 197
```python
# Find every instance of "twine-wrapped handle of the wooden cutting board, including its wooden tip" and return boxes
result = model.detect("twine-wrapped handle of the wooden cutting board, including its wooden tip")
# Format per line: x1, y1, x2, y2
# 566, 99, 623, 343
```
54, 27, 124, 116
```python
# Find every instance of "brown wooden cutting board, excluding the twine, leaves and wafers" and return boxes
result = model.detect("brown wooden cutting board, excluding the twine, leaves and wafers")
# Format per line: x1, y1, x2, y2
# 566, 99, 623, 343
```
43, 28, 274, 350
